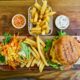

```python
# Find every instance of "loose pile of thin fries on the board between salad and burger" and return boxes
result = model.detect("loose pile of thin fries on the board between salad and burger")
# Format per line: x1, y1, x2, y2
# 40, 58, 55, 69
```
21, 36, 48, 72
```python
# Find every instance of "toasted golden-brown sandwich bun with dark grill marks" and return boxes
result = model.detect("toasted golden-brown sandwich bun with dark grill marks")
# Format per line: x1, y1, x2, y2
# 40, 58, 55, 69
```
50, 35, 80, 65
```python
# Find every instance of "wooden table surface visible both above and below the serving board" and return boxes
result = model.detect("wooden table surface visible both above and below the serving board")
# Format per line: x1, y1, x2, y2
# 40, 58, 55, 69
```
0, 0, 80, 80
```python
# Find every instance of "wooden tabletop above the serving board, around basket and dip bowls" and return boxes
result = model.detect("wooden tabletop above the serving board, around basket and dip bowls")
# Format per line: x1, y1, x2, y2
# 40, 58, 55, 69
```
0, 0, 80, 35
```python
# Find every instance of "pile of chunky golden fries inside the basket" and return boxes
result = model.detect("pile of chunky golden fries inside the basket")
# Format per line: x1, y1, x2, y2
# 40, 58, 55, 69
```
30, 0, 56, 35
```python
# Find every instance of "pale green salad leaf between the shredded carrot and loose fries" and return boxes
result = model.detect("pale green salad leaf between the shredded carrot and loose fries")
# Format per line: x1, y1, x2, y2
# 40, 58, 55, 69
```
21, 42, 31, 59
